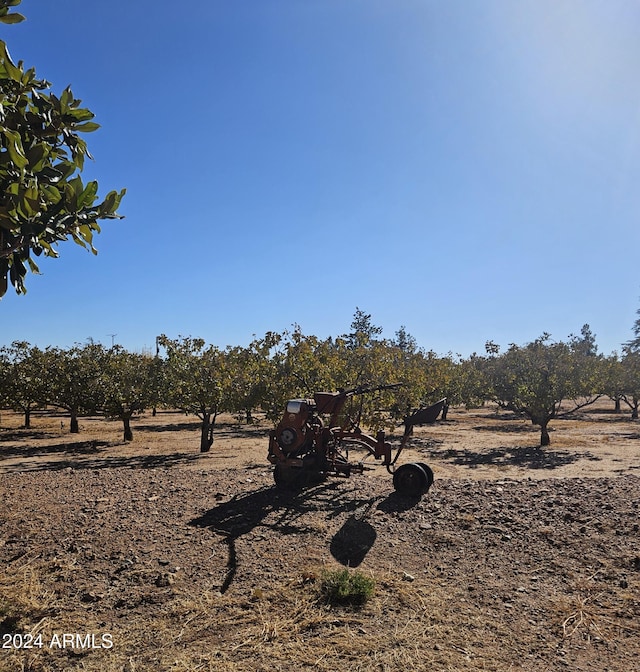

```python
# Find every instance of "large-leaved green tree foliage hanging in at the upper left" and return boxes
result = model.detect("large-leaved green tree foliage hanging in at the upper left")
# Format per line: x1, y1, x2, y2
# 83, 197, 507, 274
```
0, 0, 125, 297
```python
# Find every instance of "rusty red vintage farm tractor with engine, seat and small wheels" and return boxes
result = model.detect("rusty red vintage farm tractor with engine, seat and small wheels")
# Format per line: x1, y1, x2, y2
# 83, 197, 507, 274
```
267, 385, 446, 497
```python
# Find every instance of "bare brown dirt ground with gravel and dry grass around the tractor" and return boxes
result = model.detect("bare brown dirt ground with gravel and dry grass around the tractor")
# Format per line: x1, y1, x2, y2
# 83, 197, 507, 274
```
0, 404, 640, 672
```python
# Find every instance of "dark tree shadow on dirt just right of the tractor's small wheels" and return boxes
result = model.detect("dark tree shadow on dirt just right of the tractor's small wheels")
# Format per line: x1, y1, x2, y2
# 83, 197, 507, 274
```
431, 446, 601, 469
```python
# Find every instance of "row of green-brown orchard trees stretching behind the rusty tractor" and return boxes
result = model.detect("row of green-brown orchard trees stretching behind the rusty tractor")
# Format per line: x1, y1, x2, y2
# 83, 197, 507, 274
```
0, 309, 640, 452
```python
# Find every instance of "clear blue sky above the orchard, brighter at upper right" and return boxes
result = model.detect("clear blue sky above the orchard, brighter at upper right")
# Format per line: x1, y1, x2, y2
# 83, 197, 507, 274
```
0, 0, 640, 356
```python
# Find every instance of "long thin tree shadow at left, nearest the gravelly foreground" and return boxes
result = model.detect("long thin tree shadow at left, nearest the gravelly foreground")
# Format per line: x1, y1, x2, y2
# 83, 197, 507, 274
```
0, 452, 202, 473
